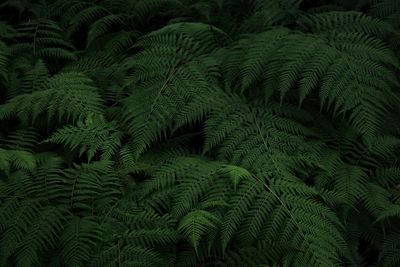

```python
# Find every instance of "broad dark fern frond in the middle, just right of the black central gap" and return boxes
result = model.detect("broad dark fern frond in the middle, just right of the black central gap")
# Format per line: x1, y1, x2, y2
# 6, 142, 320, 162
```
204, 96, 314, 170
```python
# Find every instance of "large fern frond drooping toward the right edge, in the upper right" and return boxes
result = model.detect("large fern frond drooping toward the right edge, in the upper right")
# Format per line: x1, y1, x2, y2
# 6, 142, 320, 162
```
281, 35, 395, 136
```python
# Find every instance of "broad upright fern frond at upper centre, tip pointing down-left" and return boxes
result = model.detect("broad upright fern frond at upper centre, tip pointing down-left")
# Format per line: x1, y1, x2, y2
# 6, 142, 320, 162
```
124, 23, 223, 156
